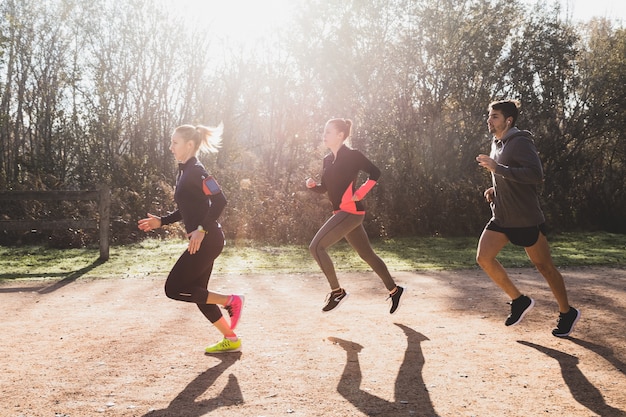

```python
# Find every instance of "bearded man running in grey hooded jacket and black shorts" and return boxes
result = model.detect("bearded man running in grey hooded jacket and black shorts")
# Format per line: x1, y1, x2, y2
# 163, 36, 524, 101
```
476, 100, 580, 337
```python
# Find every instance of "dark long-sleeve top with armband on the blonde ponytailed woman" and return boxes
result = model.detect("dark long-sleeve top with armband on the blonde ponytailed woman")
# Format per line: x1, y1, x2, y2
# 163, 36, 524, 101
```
161, 157, 227, 233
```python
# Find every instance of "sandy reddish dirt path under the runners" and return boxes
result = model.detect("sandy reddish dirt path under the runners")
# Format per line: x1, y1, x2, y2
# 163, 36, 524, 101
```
0, 268, 626, 417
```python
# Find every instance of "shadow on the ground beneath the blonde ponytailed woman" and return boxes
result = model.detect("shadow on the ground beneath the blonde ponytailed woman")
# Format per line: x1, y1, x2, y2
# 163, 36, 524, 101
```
144, 352, 244, 417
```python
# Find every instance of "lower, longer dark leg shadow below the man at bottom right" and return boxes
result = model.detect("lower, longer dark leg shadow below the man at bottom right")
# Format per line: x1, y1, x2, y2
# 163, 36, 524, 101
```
517, 340, 626, 417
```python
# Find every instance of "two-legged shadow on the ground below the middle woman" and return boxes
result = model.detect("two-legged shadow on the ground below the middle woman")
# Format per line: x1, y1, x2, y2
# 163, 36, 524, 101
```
328, 323, 437, 417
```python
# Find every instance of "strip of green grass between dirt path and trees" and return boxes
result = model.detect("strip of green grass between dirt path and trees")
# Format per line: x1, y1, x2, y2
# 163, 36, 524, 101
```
0, 233, 626, 279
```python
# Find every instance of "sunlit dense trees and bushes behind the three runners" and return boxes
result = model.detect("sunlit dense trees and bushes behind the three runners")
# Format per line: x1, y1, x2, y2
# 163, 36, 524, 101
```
0, 0, 626, 246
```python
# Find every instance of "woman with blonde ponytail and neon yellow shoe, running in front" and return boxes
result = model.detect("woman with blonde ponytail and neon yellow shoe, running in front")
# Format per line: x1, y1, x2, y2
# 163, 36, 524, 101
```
139, 124, 244, 353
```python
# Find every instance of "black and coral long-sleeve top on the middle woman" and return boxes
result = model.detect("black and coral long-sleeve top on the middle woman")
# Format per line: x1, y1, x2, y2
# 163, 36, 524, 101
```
311, 145, 380, 214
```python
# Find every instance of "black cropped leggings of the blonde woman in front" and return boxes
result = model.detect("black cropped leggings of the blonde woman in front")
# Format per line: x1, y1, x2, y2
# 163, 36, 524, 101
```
165, 227, 224, 323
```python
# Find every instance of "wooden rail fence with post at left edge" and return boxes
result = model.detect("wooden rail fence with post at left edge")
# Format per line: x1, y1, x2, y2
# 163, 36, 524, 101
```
0, 187, 111, 261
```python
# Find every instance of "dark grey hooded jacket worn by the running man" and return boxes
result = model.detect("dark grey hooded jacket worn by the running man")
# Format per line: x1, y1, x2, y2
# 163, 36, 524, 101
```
490, 127, 545, 227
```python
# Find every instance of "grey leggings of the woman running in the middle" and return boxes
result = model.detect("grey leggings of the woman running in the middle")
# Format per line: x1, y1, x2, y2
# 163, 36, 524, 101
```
309, 211, 396, 291
